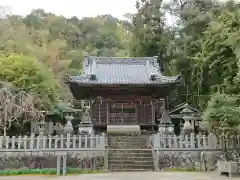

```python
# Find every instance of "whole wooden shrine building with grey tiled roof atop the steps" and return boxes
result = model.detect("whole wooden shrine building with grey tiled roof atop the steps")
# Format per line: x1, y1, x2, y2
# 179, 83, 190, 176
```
67, 56, 181, 132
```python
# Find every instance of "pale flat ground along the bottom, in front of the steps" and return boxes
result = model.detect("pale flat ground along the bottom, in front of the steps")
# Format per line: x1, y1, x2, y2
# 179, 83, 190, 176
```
0, 172, 237, 180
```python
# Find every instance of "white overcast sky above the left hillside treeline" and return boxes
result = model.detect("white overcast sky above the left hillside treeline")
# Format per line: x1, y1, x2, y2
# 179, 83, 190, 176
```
0, 0, 139, 19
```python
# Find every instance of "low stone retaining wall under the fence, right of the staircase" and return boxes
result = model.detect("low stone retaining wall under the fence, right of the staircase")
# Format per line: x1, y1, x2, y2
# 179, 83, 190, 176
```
156, 151, 227, 171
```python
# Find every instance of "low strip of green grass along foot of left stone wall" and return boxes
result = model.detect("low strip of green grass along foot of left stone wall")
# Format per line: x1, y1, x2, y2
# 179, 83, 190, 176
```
0, 168, 103, 176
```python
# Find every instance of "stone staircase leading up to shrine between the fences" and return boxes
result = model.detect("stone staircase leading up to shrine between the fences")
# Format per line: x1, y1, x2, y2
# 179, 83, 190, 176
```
108, 134, 154, 171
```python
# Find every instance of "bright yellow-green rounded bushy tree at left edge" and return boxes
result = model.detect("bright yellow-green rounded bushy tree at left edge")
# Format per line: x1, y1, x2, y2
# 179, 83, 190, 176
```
0, 54, 59, 108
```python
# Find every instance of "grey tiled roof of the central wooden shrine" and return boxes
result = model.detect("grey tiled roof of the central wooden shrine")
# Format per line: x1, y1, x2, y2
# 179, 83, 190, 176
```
67, 56, 181, 85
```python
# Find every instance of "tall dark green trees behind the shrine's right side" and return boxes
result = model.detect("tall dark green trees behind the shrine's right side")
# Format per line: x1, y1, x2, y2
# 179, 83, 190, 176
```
131, 0, 240, 109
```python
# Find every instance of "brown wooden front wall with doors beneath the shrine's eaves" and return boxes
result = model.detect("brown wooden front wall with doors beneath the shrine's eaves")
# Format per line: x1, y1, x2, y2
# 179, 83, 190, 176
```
91, 99, 156, 126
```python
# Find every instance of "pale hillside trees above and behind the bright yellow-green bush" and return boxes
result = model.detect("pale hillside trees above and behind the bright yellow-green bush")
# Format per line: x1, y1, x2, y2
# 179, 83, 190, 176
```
0, 9, 131, 106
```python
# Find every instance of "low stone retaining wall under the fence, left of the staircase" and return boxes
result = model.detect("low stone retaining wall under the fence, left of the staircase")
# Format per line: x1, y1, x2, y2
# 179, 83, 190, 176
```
0, 152, 104, 170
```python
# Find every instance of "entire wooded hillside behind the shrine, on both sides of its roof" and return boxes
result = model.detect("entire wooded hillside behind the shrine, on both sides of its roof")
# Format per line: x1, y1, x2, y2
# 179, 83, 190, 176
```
0, 0, 240, 119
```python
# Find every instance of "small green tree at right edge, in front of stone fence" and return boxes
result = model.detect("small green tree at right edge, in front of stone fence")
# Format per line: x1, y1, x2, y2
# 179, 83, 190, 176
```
203, 93, 240, 160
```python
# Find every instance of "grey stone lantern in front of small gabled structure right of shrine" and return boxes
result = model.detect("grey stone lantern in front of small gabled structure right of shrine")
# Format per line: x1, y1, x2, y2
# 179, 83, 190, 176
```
181, 103, 194, 134
